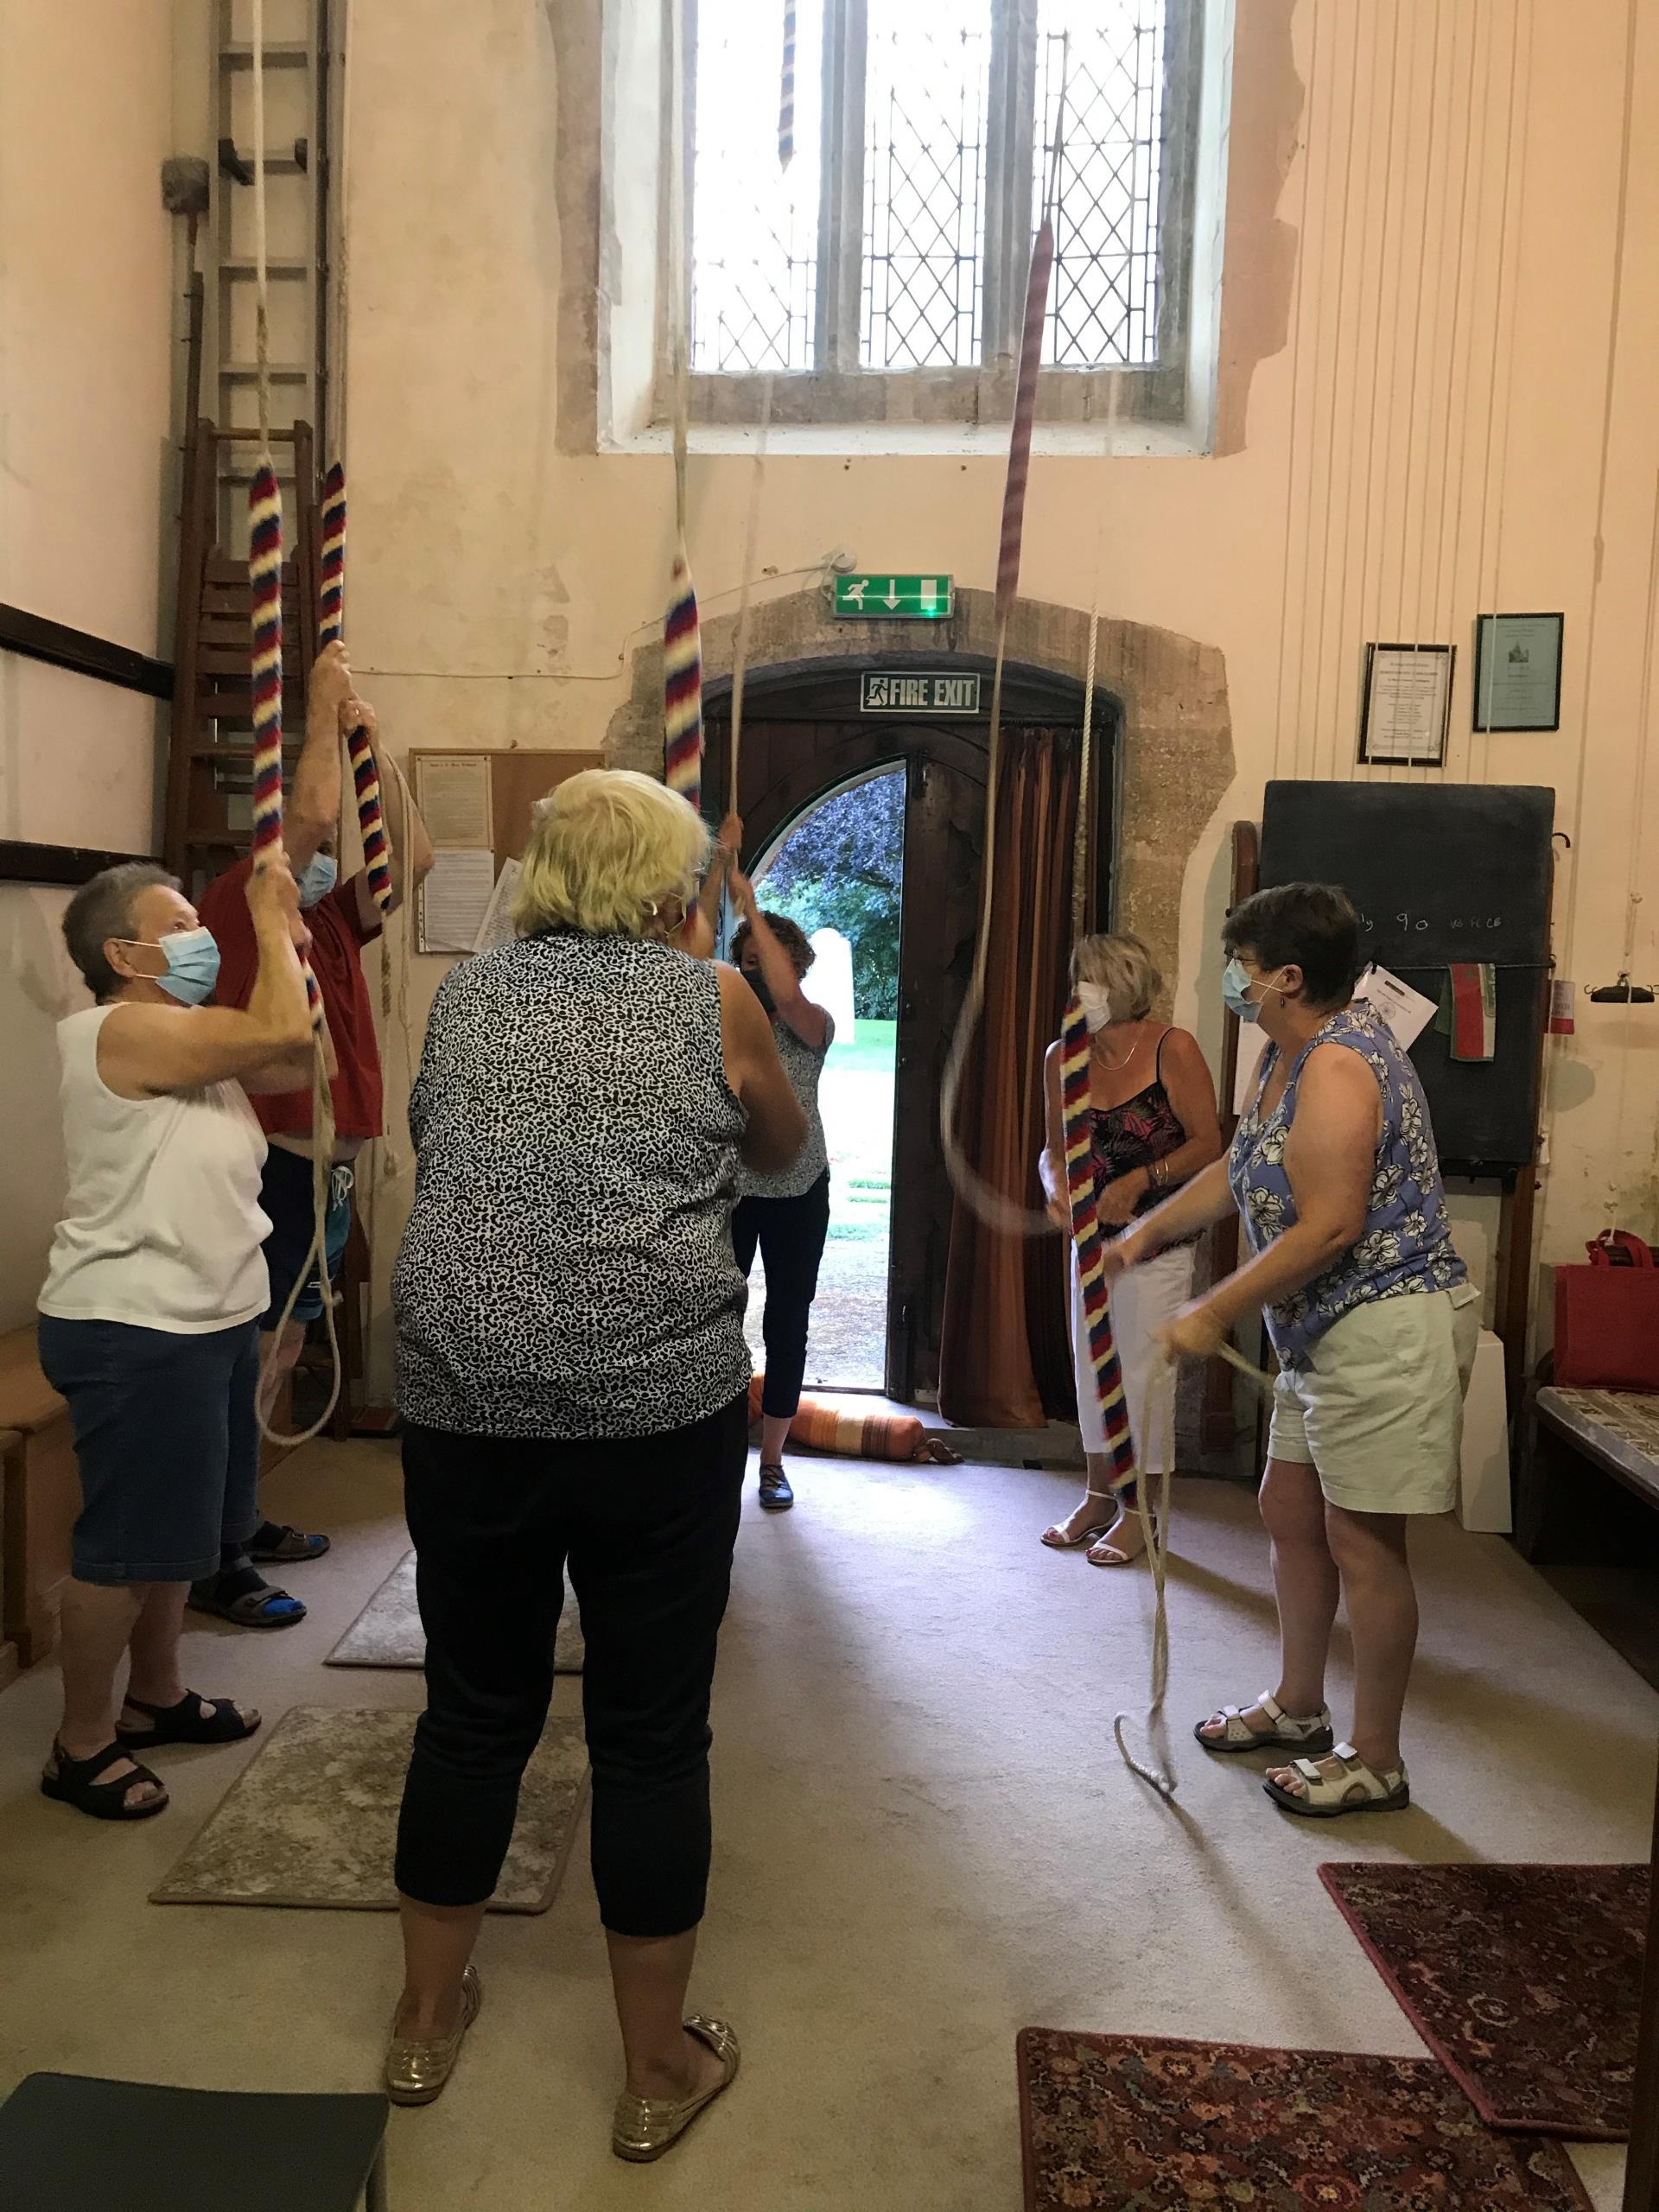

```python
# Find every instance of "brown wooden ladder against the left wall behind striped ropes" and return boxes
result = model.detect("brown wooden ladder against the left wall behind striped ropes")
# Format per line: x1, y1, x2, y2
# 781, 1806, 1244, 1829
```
162, 420, 319, 898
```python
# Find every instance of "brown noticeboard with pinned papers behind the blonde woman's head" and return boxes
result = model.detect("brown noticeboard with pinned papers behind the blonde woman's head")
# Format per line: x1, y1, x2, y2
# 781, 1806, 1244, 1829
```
410, 746, 600, 960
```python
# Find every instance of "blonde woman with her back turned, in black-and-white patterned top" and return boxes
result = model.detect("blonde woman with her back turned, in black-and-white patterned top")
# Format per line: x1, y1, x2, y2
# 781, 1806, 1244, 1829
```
387, 770, 805, 2161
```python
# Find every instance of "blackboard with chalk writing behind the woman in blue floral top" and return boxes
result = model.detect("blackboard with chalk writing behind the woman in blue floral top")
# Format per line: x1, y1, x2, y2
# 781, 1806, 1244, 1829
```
1261, 783, 1555, 1177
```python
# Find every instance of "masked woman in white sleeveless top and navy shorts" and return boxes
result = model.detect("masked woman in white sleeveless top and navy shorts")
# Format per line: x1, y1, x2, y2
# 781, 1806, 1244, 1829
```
40, 861, 312, 1821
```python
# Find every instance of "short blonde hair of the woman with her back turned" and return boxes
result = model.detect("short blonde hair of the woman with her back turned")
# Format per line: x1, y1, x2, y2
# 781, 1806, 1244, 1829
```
513, 767, 710, 938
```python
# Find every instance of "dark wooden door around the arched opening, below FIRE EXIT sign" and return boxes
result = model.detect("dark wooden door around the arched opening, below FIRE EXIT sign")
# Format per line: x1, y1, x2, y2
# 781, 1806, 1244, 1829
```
703, 652, 1117, 1402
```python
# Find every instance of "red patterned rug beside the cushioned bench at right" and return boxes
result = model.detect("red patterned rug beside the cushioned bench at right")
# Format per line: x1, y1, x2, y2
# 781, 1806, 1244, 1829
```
1319, 1865, 1648, 2141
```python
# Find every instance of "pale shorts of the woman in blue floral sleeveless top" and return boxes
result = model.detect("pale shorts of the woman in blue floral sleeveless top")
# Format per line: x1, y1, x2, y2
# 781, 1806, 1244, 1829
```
1268, 1283, 1480, 1513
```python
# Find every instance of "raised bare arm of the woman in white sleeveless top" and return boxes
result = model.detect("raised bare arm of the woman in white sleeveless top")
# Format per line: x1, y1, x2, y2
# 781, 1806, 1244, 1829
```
98, 862, 312, 1099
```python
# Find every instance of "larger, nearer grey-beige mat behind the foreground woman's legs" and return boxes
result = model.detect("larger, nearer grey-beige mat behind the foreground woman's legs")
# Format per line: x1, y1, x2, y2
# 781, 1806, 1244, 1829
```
150, 1706, 588, 1913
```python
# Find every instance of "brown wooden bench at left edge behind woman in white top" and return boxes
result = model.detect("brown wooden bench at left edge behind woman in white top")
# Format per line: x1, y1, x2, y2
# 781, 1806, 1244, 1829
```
0, 1327, 79, 1666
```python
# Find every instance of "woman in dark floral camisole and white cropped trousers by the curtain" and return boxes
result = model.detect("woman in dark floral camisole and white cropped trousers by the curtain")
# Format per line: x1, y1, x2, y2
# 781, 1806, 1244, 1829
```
1042, 936, 1221, 1566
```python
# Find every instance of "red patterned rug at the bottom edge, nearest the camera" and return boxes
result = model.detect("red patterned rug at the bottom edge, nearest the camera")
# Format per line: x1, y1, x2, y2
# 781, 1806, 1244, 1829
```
1018, 2029, 1591, 2212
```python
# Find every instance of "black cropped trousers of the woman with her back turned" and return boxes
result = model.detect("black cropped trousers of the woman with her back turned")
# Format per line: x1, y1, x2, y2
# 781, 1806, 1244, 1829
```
396, 1395, 747, 1936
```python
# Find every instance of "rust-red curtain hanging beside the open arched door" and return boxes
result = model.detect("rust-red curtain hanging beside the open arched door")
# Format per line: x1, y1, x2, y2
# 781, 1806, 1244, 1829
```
938, 730, 1079, 1429
